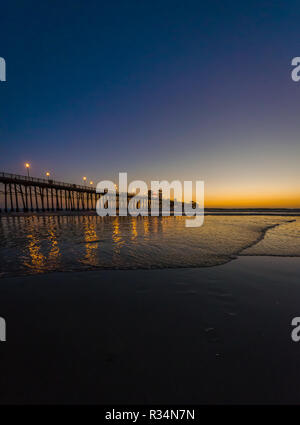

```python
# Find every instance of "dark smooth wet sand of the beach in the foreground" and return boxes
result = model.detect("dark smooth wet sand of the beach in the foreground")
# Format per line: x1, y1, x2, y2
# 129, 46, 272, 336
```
0, 257, 300, 404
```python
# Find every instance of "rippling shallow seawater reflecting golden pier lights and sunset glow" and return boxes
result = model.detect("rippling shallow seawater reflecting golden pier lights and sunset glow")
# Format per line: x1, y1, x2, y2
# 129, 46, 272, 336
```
0, 215, 300, 276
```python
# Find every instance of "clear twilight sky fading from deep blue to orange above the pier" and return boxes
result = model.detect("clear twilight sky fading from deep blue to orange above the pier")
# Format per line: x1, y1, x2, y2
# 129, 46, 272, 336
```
0, 0, 300, 207
